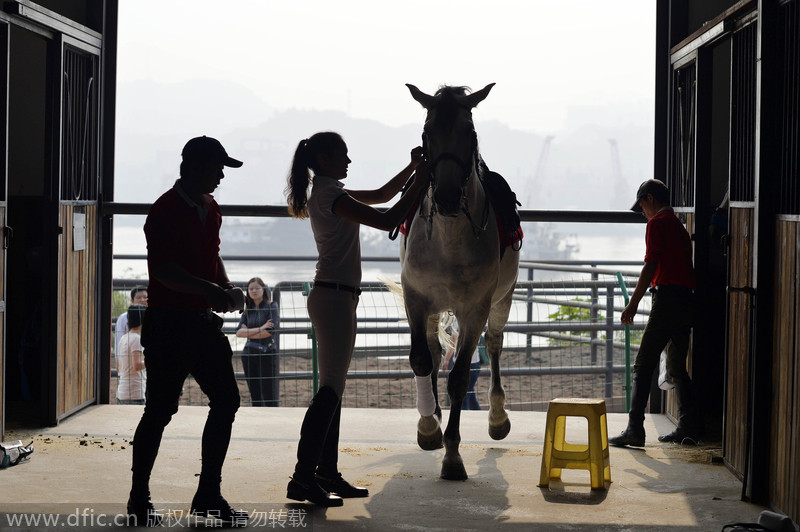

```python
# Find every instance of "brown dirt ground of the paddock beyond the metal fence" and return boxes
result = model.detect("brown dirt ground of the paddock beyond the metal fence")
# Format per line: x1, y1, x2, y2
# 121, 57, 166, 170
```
111, 346, 625, 412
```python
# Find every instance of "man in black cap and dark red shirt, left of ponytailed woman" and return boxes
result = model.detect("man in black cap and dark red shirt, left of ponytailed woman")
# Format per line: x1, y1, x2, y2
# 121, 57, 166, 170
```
128, 136, 247, 526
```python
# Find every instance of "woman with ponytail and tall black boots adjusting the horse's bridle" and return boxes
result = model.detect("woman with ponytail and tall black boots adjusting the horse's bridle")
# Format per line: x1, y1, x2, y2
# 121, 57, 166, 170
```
286, 132, 428, 506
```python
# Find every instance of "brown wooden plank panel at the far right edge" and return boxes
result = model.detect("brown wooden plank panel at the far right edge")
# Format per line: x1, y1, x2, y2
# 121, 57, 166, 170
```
770, 221, 800, 516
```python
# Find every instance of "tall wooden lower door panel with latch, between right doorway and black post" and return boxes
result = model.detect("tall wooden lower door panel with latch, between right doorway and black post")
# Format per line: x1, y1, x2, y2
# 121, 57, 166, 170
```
724, 208, 753, 476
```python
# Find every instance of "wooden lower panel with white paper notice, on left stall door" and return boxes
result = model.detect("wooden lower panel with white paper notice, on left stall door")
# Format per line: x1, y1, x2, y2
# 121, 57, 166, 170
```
57, 205, 97, 418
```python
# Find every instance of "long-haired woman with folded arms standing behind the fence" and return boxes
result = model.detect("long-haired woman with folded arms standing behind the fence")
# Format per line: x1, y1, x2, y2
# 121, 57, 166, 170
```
236, 277, 280, 406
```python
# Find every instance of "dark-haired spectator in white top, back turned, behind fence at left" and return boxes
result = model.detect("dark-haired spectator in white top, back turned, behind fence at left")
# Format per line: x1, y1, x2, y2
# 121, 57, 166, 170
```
117, 305, 147, 405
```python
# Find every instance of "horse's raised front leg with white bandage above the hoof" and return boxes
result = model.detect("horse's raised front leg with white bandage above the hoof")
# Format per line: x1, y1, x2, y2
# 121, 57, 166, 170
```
404, 289, 442, 451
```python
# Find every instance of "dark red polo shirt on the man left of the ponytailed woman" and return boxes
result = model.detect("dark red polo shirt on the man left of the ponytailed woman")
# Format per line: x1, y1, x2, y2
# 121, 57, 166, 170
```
144, 184, 222, 310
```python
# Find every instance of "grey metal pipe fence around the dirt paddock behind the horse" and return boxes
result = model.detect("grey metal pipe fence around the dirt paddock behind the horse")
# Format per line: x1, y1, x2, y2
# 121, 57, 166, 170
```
112, 255, 647, 408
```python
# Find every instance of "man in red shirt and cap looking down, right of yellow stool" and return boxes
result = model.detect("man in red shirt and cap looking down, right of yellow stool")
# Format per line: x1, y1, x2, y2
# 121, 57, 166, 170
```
609, 179, 700, 447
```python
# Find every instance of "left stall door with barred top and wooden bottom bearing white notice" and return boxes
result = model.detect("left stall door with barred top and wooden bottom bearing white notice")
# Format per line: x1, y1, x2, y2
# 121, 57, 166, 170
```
55, 36, 100, 419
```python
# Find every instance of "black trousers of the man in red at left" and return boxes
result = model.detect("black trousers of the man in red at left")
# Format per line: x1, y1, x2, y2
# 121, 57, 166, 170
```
132, 307, 239, 493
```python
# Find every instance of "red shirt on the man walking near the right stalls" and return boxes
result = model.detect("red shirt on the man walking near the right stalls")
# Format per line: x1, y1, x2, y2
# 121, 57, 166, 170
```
644, 208, 695, 289
